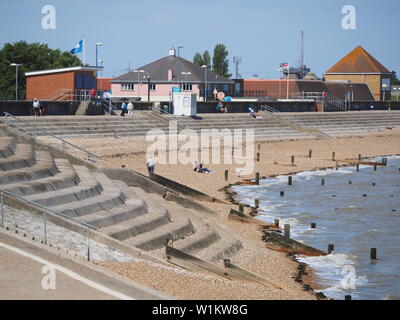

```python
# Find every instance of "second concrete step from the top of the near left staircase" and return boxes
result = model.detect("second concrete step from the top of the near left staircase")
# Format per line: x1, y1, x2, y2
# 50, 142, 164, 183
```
0, 143, 36, 171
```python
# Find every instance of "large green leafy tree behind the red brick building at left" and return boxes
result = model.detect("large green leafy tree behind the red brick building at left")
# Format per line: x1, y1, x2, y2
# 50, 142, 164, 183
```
0, 41, 83, 99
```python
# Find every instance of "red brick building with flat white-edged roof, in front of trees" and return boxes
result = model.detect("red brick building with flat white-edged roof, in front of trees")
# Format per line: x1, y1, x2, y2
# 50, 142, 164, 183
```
25, 67, 103, 100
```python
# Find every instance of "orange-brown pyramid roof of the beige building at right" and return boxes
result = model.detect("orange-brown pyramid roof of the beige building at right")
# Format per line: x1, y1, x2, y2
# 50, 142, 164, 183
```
326, 46, 390, 73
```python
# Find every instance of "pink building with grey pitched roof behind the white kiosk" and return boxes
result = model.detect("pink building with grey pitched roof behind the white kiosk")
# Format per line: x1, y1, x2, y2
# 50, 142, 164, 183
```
111, 49, 234, 101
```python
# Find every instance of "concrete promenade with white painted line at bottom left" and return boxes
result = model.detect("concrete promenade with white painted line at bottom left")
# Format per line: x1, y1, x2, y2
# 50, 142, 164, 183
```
0, 230, 167, 300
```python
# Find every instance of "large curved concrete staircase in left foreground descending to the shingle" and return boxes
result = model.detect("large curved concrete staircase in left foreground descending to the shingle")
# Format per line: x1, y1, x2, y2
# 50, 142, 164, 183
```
0, 131, 241, 261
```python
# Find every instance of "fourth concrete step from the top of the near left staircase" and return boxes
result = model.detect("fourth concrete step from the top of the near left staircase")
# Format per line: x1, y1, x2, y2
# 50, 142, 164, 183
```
2, 158, 80, 196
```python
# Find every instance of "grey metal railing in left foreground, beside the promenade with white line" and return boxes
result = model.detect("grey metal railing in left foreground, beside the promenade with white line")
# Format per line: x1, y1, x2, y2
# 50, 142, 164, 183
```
0, 189, 98, 261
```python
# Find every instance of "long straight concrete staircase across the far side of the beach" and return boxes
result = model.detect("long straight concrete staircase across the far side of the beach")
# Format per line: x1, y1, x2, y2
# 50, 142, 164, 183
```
3, 111, 400, 140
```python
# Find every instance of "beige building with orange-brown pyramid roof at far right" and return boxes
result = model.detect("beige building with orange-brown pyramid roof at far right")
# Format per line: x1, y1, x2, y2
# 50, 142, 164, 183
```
325, 46, 393, 101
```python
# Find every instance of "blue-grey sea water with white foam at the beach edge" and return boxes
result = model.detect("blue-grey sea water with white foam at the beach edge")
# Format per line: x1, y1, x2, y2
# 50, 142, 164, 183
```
234, 156, 400, 299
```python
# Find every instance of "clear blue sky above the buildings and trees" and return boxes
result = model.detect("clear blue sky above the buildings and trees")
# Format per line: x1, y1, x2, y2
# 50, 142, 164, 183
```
0, 0, 400, 78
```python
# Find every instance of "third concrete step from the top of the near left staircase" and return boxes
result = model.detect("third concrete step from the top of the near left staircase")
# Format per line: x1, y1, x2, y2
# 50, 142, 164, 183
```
0, 151, 58, 185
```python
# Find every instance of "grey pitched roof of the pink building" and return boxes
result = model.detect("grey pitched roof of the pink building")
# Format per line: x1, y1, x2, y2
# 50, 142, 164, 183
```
111, 56, 234, 84
